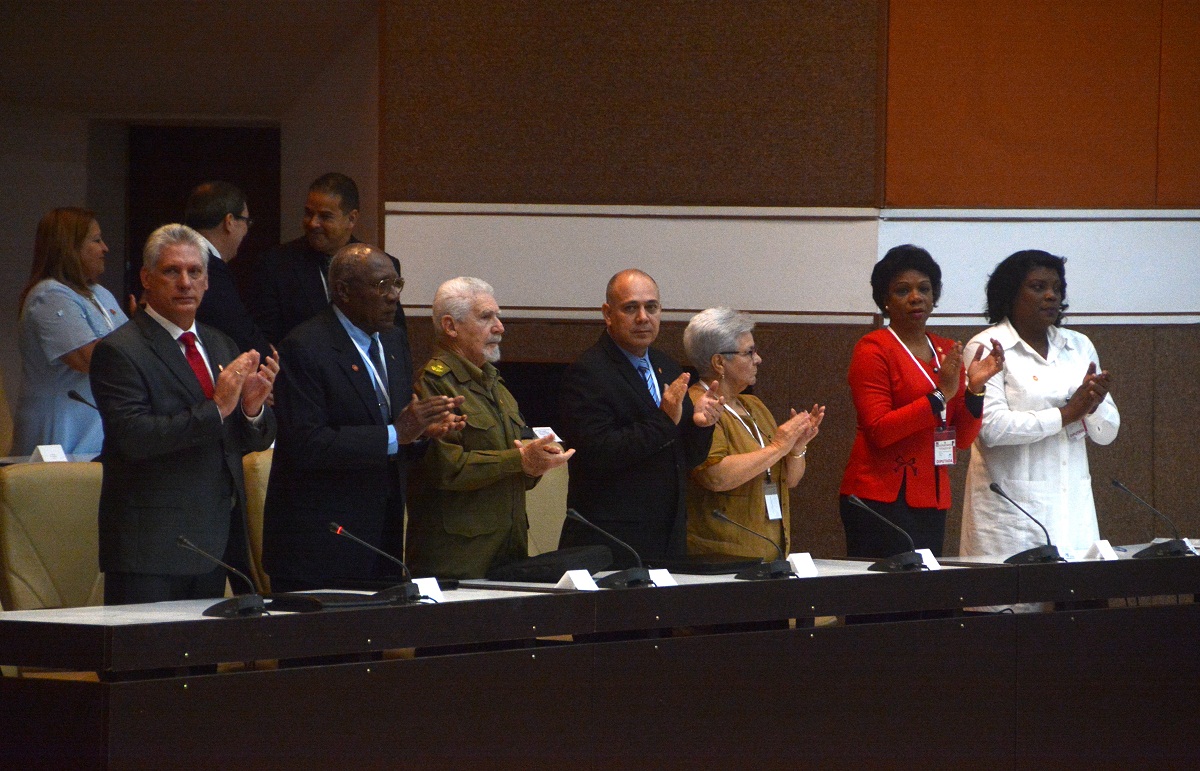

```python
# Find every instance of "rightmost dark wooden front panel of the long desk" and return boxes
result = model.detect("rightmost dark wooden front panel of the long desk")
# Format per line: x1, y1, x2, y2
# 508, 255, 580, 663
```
1016, 603, 1200, 769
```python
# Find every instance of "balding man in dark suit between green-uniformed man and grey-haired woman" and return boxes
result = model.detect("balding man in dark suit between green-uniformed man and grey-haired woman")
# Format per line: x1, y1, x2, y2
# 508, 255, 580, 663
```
558, 270, 724, 567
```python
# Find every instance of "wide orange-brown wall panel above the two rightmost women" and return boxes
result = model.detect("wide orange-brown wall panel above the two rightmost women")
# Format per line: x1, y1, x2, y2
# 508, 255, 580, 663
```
886, 0, 1161, 208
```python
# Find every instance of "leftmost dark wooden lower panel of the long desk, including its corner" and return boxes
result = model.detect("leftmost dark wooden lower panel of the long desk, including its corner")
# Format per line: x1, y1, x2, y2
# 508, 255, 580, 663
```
0, 646, 592, 770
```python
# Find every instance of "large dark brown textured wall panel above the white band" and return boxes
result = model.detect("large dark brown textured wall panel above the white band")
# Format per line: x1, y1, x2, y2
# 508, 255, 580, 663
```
380, 0, 886, 207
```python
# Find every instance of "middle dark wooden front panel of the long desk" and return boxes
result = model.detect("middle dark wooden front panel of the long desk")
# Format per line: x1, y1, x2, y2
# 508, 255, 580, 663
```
585, 616, 1016, 769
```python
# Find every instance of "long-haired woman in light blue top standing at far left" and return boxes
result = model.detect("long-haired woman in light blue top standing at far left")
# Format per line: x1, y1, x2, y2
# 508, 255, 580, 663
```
13, 208, 127, 455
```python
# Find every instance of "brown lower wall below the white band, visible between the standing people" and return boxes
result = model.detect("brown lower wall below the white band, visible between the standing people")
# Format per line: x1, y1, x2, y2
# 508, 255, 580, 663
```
409, 312, 1200, 557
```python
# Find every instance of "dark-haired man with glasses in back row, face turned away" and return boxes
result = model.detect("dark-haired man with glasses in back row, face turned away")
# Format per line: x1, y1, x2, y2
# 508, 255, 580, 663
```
184, 181, 271, 357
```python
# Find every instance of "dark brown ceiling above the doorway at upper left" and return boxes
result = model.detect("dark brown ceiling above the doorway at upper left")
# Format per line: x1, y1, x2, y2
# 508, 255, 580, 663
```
0, 0, 379, 118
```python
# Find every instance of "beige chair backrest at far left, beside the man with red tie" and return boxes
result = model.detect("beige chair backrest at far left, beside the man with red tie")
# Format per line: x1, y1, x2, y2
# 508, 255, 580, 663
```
0, 462, 103, 610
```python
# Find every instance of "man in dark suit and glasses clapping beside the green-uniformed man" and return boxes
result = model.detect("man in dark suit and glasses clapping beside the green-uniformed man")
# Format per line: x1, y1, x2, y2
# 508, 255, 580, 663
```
263, 244, 466, 591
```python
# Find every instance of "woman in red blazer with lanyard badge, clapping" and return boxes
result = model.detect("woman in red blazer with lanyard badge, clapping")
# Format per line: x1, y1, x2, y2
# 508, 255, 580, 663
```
841, 244, 1004, 558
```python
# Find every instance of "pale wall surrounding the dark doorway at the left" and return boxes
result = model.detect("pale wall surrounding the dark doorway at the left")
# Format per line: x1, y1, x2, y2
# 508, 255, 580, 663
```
0, 17, 380, 408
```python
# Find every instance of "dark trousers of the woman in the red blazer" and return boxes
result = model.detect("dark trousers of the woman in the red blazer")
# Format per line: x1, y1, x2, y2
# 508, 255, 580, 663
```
839, 486, 946, 560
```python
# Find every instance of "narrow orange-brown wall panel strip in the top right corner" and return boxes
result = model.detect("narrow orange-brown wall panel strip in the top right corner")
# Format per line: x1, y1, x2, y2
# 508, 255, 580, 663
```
1158, 0, 1200, 209
